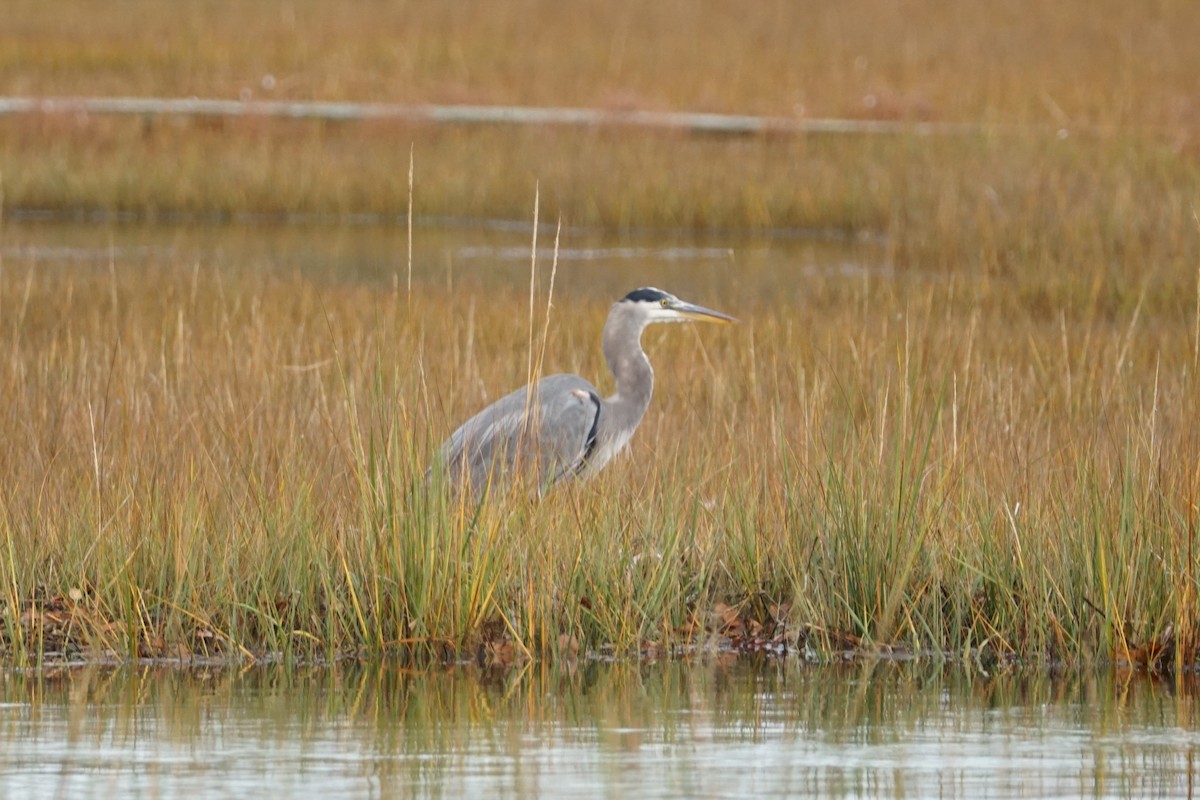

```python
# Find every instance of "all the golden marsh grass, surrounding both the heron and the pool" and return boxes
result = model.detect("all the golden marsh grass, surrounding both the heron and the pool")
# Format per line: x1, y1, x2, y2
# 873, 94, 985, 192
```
0, 0, 1200, 668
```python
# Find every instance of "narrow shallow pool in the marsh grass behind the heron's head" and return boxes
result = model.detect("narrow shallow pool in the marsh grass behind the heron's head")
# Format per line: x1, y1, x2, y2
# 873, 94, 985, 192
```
0, 215, 894, 302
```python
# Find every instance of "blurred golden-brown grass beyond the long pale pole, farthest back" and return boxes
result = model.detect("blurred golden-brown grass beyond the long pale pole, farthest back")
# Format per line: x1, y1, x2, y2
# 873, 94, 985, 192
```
7, 0, 1200, 126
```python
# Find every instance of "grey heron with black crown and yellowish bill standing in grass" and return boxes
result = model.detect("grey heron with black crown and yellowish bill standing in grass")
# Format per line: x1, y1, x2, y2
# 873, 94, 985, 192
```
440, 288, 737, 494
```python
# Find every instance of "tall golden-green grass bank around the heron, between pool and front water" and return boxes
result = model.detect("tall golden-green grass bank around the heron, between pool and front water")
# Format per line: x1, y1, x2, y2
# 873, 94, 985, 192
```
0, 244, 1200, 669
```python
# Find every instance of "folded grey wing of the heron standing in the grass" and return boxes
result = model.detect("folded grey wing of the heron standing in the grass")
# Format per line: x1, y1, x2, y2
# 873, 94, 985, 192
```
442, 375, 600, 492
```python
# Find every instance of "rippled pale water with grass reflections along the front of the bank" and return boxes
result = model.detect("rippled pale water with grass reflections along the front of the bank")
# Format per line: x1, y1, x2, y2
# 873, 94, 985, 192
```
0, 660, 1200, 798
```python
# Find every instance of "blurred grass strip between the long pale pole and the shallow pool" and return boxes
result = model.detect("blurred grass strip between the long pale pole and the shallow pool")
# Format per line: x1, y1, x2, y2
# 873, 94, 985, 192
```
7, 116, 1200, 275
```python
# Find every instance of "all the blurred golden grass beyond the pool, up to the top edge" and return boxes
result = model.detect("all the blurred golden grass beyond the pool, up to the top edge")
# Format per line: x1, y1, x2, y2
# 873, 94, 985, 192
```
0, 0, 1200, 265
